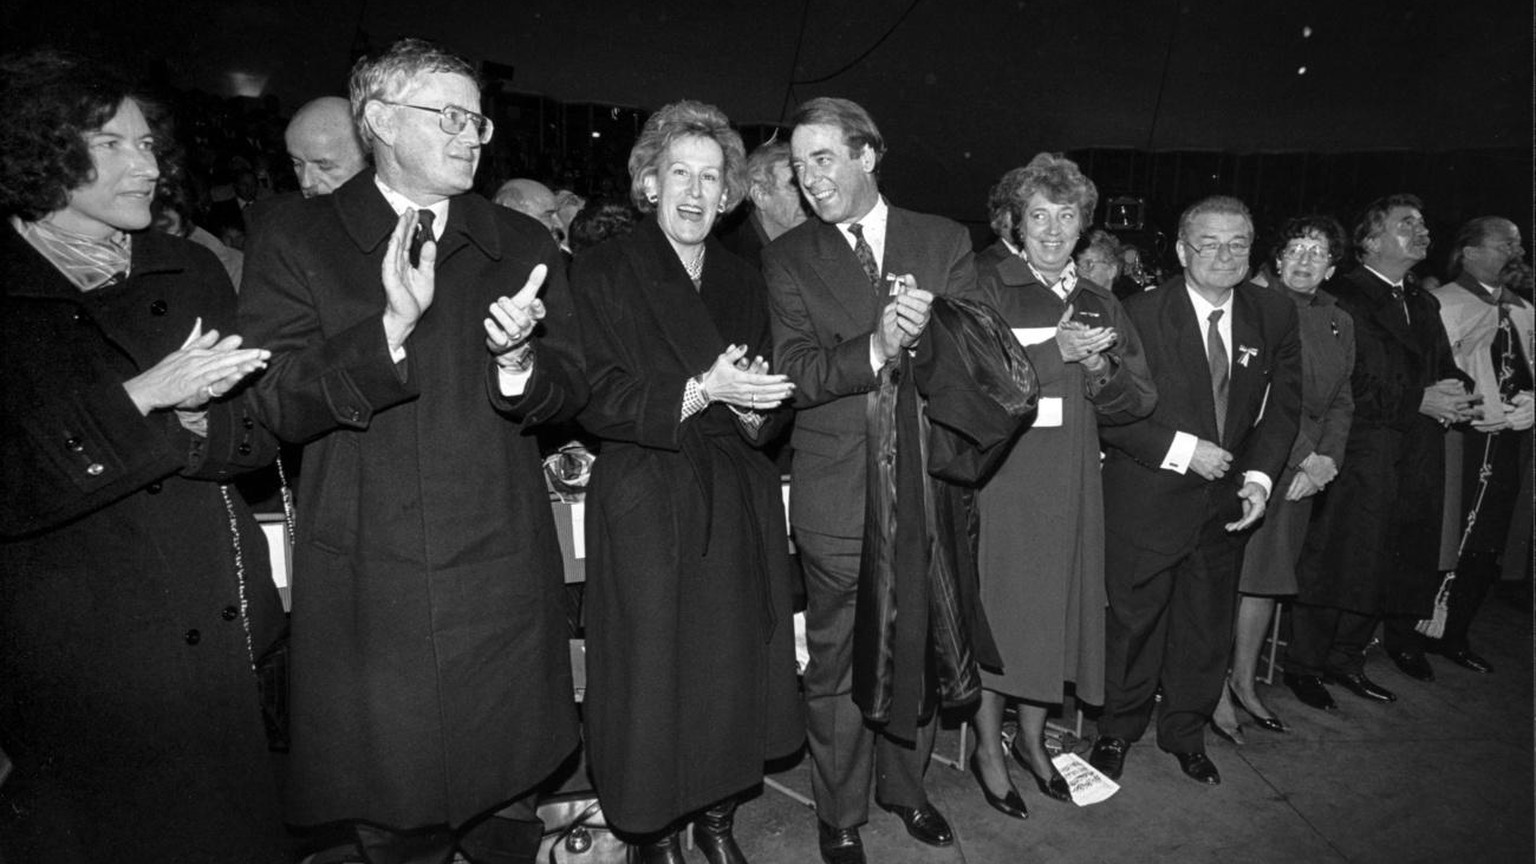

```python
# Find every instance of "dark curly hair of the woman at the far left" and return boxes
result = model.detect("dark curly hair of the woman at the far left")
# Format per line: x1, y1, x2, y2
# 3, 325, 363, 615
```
0, 49, 167, 221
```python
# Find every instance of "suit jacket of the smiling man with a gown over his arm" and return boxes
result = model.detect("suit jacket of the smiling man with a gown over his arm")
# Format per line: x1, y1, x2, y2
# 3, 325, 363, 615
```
763, 206, 975, 538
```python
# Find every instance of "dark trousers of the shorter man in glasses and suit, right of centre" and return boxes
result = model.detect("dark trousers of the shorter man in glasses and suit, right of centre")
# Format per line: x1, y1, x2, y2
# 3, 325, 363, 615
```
1098, 520, 1243, 753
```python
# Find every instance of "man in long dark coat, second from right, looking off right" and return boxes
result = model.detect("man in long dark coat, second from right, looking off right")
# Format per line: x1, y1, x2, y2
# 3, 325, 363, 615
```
1284, 195, 1476, 710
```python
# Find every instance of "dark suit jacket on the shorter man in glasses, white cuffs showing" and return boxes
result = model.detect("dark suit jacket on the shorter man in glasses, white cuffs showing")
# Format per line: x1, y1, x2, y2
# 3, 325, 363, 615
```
1098, 275, 1301, 555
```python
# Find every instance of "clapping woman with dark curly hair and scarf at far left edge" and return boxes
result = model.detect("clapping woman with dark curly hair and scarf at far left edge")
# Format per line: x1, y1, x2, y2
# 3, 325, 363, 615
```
0, 52, 287, 864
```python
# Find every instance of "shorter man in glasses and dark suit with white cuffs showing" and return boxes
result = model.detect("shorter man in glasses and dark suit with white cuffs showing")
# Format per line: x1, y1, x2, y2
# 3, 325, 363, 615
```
1089, 197, 1301, 784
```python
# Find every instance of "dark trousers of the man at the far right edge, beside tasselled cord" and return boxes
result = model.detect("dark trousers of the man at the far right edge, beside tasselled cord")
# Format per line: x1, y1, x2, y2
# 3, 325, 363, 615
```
1441, 430, 1530, 650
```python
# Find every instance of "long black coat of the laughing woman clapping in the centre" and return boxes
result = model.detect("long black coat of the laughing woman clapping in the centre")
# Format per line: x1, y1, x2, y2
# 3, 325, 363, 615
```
571, 220, 803, 833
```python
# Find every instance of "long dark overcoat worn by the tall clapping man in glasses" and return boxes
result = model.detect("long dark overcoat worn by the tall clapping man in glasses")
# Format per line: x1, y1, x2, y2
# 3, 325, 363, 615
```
240, 172, 584, 829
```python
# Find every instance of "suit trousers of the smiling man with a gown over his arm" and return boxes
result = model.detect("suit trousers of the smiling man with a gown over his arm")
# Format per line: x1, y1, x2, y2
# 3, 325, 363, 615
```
794, 529, 934, 829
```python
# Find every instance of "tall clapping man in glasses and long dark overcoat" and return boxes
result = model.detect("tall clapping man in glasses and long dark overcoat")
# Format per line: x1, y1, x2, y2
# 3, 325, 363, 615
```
241, 40, 585, 862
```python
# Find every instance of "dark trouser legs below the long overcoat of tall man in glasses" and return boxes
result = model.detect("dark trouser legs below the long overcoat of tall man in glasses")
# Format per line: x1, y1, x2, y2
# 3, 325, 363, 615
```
355, 795, 544, 864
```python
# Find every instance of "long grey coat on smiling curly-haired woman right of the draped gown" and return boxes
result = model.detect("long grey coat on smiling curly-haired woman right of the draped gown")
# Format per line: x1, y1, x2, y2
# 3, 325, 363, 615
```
958, 255, 1157, 704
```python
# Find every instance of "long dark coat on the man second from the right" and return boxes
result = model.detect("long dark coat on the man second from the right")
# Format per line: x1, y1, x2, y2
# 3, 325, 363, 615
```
1296, 268, 1470, 618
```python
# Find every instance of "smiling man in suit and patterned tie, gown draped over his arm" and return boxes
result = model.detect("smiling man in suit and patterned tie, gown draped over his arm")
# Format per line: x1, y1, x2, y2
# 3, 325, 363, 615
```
763, 98, 975, 864
